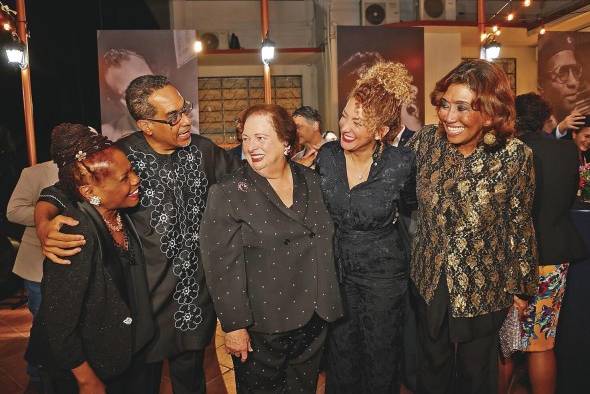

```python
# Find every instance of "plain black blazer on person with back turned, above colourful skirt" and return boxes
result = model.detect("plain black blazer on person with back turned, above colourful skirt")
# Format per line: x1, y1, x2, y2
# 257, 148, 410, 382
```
520, 132, 586, 265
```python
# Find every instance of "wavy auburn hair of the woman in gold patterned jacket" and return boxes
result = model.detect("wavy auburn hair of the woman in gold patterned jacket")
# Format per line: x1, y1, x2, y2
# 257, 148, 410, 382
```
430, 59, 516, 151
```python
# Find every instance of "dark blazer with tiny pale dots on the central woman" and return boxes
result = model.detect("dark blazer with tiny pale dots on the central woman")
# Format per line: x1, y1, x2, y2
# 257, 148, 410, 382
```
200, 162, 342, 333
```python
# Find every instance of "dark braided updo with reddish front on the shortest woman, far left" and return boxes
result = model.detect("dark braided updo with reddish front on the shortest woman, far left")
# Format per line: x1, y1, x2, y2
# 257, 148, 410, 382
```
51, 123, 120, 201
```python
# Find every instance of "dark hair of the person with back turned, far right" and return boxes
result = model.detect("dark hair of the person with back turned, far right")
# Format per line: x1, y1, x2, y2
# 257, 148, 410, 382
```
515, 92, 551, 135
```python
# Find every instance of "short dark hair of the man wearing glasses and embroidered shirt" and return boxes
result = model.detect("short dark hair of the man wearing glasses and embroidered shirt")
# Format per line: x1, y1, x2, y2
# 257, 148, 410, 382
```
125, 75, 172, 120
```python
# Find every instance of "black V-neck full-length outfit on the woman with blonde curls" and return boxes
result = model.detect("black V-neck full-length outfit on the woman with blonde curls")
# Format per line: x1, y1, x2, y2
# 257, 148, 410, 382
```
316, 141, 416, 394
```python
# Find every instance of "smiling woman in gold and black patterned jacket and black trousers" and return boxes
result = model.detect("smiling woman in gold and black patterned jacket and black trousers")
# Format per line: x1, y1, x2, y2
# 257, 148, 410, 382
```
409, 60, 537, 394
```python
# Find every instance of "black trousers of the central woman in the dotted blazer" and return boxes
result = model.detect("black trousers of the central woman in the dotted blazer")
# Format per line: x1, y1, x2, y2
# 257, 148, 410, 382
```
232, 314, 328, 394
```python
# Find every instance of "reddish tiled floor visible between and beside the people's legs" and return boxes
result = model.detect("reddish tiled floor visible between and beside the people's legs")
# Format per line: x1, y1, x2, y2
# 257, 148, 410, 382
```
0, 290, 324, 394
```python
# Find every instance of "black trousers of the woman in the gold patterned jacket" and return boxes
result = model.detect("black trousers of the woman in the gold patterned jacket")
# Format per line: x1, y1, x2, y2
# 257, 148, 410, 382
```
413, 275, 506, 394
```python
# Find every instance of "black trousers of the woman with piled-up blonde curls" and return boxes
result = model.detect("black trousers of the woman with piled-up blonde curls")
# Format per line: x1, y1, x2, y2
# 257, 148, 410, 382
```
326, 273, 407, 394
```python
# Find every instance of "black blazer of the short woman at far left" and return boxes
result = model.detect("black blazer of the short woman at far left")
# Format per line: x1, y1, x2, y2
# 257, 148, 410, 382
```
27, 203, 153, 380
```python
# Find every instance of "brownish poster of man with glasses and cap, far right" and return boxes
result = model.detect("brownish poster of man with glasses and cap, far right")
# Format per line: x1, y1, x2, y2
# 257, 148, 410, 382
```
538, 32, 590, 138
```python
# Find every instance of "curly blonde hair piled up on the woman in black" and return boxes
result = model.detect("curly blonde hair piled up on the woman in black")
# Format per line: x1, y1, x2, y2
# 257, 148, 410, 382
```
348, 62, 412, 142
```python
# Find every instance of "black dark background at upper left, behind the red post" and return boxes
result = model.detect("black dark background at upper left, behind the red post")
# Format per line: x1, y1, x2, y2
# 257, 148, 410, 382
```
0, 0, 170, 238
